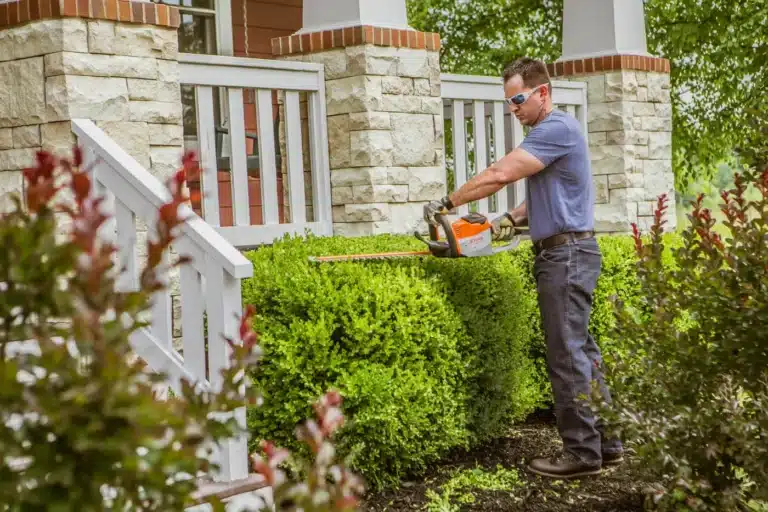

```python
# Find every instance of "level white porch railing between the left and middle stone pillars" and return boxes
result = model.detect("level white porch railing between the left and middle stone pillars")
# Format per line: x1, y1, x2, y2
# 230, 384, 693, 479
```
179, 54, 332, 249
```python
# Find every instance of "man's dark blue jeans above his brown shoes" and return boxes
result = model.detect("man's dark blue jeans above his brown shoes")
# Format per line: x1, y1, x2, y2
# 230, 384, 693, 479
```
534, 237, 622, 464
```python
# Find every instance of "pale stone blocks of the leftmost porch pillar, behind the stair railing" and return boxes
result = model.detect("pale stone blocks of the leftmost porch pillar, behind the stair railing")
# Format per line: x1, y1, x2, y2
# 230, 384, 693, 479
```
0, 13, 183, 348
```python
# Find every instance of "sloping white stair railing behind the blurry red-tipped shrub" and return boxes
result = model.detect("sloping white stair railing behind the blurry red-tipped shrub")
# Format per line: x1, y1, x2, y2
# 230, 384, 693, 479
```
72, 120, 253, 481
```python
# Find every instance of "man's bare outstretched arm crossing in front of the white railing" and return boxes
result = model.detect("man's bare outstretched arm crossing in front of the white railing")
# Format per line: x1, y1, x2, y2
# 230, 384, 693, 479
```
449, 147, 544, 213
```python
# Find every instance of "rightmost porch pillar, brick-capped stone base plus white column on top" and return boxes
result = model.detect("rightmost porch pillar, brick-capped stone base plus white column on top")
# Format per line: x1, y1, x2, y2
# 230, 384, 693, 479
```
549, 0, 676, 233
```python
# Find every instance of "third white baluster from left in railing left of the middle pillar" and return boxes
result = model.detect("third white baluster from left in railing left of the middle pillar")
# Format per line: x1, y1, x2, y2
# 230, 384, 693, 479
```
256, 89, 280, 225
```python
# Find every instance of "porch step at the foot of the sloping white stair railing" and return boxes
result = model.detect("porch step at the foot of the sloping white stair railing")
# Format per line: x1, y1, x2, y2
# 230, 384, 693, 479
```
185, 473, 272, 512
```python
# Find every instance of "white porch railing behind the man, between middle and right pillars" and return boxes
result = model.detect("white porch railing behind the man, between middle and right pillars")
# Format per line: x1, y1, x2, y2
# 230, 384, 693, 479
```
441, 74, 587, 215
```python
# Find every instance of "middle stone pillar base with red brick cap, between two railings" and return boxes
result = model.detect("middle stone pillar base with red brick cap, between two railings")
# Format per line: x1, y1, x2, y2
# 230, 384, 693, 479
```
272, 25, 446, 236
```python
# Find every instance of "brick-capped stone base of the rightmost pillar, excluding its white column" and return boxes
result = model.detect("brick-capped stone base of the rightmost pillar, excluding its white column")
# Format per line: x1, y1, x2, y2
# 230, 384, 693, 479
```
549, 55, 676, 233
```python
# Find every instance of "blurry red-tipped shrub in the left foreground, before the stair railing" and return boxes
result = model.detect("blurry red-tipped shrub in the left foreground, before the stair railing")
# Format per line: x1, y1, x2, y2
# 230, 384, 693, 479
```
0, 148, 361, 512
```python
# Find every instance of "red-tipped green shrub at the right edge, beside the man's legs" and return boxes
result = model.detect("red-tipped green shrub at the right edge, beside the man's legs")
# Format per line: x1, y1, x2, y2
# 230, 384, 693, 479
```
593, 169, 768, 511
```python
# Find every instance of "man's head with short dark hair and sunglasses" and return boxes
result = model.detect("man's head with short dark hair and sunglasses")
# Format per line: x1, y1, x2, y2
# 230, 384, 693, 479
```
504, 57, 552, 126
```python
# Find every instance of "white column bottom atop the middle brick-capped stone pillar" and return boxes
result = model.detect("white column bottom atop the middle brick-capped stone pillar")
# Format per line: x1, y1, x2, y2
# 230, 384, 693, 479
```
297, 0, 410, 34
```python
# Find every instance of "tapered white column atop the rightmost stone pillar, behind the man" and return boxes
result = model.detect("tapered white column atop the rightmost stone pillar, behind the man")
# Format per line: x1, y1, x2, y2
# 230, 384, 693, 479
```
560, 0, 650, 61
